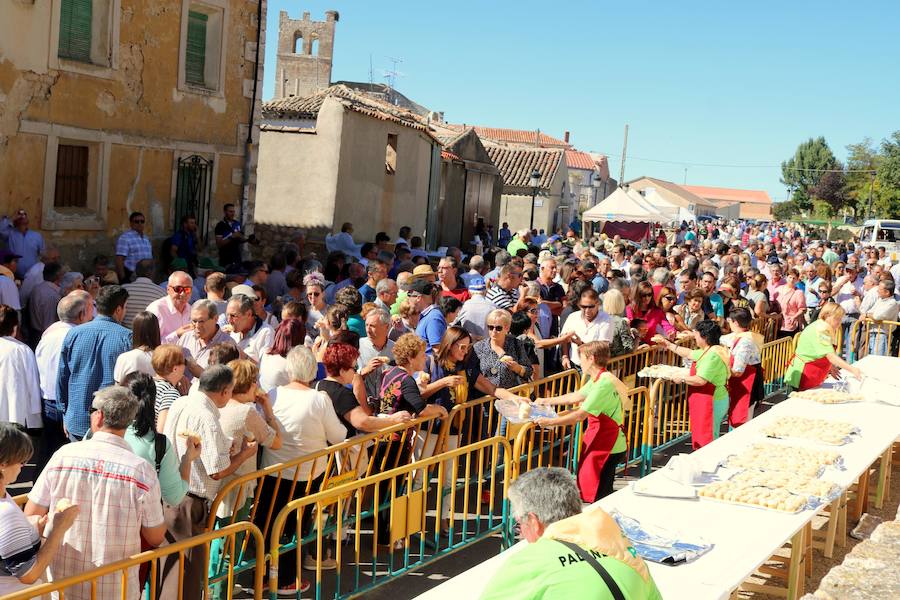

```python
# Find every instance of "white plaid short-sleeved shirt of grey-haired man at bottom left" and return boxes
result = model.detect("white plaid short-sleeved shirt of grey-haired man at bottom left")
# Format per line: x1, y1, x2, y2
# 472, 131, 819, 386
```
28, 431, 163, 600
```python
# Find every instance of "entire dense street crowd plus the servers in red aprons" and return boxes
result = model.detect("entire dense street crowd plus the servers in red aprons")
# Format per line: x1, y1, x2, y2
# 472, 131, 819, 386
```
0, 205, 900, 598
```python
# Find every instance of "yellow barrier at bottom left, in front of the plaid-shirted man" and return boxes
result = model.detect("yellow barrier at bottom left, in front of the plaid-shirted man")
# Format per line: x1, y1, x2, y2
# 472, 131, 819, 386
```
3, 522, 265, 600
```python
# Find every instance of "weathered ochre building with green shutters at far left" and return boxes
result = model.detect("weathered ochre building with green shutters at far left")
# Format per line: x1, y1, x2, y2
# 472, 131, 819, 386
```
0, 0, 266, 267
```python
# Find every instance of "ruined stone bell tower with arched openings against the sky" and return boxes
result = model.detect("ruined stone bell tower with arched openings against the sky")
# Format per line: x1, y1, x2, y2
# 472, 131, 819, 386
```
275, 10, 340, 98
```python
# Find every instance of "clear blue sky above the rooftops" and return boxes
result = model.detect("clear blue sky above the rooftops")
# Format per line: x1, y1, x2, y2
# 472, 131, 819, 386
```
263, 0, 900, 201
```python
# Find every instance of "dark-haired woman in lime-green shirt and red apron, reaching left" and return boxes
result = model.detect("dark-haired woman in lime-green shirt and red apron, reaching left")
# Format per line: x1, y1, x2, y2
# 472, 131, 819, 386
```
653, 319, 731, 450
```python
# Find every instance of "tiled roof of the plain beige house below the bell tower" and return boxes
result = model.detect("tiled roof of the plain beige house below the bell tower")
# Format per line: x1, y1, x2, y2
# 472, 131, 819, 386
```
263, 85, 431, 135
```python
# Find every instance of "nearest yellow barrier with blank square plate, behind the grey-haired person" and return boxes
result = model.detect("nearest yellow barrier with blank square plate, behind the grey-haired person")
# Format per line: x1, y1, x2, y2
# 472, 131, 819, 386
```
269, 436, 511, 600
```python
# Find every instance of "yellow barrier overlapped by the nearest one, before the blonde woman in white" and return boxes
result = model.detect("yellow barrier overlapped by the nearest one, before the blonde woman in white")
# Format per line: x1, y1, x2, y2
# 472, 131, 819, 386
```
207, 418, 449, 573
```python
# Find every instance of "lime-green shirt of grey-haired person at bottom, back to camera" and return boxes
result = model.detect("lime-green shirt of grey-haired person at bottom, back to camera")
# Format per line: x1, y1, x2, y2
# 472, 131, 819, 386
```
481, 538, 662, 600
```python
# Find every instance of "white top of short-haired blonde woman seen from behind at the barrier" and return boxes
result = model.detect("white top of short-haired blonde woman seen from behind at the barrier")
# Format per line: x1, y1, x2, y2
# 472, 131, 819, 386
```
262, 387, 347, 481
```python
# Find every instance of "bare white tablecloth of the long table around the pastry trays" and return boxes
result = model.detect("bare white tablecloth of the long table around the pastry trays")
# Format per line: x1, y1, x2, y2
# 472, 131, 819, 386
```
419, 357, 900, 600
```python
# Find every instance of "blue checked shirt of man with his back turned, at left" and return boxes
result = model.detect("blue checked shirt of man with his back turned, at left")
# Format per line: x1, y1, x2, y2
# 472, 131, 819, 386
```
56, 315, 131, 437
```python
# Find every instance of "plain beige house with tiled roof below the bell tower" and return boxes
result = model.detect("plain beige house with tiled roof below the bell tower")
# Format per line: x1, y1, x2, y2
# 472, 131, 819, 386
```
256, 85, 441, 242
